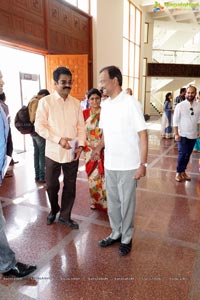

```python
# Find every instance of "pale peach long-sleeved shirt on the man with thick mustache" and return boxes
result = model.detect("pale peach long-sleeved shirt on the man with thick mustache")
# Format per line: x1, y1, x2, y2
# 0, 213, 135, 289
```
35, 91, 86, 163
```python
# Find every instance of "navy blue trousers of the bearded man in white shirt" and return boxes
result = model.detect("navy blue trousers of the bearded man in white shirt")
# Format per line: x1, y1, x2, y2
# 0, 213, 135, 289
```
176, 137, 196, 173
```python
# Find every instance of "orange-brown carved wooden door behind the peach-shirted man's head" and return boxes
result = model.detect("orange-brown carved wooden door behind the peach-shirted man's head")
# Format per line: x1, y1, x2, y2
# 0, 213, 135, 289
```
46, 54, 88, 100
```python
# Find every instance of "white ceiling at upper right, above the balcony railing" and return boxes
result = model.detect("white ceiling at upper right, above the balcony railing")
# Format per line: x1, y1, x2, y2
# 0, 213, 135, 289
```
140, 0, 200, 51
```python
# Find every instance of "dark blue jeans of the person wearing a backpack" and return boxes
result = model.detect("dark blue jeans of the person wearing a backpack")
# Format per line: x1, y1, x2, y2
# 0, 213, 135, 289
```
31, 133, 46, 180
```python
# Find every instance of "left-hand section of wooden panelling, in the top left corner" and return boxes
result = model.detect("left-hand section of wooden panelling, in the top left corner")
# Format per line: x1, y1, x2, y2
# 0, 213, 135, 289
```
0, 0, 46, 50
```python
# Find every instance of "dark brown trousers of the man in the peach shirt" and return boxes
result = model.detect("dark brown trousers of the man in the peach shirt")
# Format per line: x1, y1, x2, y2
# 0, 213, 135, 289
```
46, 157, 79, 221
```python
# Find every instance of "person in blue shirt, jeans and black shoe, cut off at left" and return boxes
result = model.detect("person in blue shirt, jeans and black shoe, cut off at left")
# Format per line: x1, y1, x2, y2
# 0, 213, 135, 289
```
0, 106, 36, 277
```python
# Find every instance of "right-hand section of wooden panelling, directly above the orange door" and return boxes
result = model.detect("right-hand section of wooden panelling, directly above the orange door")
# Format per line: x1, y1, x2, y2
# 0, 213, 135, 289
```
48, 0, 90, 54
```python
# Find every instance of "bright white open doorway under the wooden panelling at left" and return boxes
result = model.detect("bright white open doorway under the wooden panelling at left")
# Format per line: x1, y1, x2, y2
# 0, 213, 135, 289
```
0, 45, 46, 153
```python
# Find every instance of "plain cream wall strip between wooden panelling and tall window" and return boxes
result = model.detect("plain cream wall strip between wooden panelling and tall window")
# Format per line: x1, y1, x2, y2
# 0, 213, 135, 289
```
91, 0, 123, 87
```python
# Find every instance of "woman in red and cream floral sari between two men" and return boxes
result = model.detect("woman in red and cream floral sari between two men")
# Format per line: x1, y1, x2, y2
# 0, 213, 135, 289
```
83, 89, 107, 211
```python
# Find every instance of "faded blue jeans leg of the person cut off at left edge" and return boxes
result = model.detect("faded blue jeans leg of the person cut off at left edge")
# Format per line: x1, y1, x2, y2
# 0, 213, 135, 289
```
0, 206, 16, 273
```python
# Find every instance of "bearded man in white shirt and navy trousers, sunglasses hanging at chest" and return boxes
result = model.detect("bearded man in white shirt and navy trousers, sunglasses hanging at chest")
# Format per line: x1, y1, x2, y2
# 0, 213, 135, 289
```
173, 86, 200, 182
